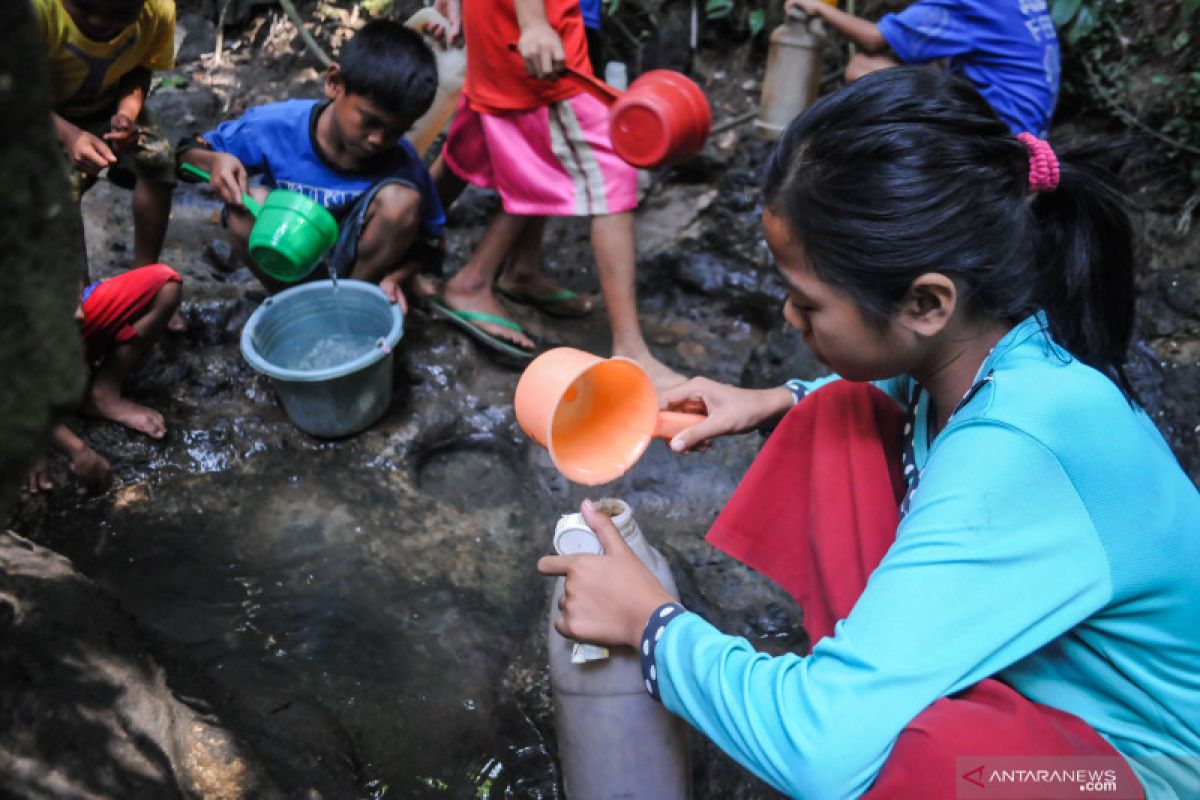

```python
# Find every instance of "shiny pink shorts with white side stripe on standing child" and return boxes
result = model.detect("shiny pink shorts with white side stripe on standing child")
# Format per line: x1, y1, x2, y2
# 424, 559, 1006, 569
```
443, 95, 637, 217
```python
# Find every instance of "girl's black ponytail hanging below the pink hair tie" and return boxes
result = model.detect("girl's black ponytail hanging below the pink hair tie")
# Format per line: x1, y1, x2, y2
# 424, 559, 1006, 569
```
1033, 152, 1134, 397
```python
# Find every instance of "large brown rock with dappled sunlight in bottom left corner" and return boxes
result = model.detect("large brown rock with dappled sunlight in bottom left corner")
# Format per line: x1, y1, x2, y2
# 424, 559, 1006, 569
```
0, 533, 283, 798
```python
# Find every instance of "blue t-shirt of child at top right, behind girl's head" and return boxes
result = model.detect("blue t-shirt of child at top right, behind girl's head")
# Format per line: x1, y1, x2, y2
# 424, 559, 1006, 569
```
880, 0, 1060, 137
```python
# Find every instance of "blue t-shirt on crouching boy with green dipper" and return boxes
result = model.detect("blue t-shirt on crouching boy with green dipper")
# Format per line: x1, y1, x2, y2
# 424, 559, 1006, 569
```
202, 100, 445, 239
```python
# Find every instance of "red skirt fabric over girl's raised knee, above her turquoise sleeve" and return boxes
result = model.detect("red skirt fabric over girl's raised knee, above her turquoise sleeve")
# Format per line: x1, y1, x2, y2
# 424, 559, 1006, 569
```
708, 380, 905, 644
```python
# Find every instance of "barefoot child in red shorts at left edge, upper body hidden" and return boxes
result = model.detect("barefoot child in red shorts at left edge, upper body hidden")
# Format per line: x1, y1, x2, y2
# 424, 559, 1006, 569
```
25, 264, 181, 494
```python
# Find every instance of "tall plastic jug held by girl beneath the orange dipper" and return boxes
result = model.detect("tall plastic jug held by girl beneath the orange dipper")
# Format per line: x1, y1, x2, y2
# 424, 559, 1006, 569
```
550, 499, 691, 800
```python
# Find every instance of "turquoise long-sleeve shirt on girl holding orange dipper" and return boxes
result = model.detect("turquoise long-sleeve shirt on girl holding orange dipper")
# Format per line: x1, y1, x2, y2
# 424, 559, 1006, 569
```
653, 315, 1200, 800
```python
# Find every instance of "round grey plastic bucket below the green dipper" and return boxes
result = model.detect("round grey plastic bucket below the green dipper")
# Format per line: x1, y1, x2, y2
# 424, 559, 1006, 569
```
241, 279, 404, 438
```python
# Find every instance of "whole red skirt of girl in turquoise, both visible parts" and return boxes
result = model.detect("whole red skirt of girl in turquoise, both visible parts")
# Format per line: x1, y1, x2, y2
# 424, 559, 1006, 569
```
708, 380, 1144, 800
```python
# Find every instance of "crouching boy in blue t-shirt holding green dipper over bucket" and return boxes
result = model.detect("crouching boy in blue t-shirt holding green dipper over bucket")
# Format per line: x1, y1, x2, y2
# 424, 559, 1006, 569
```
180, 20, 445, 309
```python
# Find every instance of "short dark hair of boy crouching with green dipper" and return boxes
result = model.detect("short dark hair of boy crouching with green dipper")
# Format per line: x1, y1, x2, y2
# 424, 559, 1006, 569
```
337, 19, 438, 121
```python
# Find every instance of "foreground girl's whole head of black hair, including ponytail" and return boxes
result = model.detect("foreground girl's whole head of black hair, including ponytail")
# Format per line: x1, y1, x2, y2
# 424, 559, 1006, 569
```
764, 67, 1134, 397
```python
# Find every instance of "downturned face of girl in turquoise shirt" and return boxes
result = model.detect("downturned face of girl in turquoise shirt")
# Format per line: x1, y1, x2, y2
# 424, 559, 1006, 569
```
762, 211, 914, 380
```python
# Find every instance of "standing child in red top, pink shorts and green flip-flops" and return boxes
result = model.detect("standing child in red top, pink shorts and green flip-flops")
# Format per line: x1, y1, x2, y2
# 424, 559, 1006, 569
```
433, 0, 683, 389
